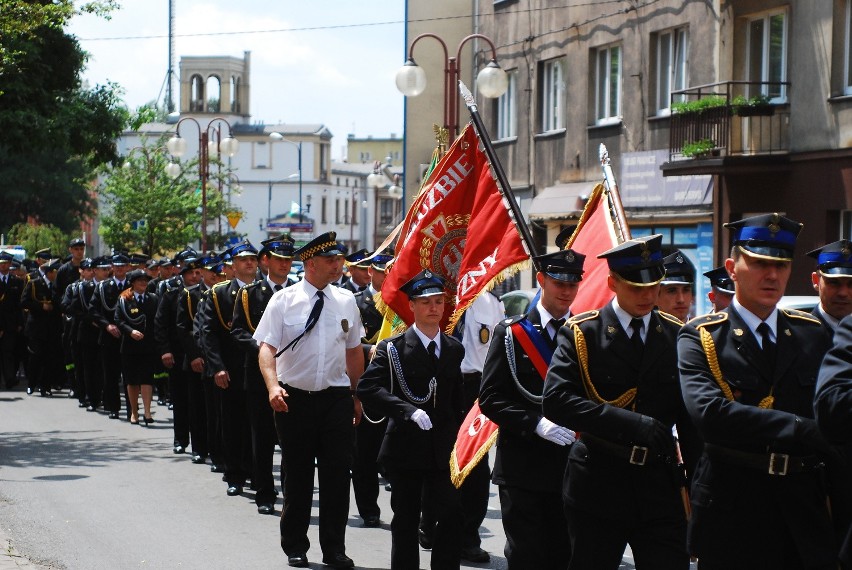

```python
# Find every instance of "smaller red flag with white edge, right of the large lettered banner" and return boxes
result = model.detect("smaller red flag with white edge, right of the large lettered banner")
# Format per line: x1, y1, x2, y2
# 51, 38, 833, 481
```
565, 184, 619, 315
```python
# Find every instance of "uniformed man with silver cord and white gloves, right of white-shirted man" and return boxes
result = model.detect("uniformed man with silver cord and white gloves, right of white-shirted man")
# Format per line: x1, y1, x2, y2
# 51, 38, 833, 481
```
358, 270, 464, 570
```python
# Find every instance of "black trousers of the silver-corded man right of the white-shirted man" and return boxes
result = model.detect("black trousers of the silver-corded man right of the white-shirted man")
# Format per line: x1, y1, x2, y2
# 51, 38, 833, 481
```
386, 465, 461, 570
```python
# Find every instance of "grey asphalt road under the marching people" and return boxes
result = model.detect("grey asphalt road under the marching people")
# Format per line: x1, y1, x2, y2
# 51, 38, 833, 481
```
0, 387, 644, 570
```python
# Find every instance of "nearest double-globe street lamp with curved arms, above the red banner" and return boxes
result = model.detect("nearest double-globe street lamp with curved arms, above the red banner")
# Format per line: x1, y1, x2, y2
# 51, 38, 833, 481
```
396, 33, 509, 141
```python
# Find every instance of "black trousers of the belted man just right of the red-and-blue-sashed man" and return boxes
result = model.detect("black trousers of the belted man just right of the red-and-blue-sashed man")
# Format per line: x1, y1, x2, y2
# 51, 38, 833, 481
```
566, 502, 689, 570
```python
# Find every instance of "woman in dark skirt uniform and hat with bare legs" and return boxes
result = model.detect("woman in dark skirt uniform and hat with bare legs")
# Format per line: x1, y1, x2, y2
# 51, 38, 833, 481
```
115, 269, 159, 426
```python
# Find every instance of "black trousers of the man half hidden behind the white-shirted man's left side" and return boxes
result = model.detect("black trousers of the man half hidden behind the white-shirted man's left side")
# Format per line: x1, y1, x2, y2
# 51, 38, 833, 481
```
245, 390, 284, 504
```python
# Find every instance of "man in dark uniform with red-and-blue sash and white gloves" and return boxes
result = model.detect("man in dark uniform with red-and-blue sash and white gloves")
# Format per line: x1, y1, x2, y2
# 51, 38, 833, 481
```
479, 249, 586, 570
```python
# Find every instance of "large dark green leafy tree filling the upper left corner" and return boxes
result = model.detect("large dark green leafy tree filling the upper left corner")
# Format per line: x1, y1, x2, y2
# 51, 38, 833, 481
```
0, 0, 129, 231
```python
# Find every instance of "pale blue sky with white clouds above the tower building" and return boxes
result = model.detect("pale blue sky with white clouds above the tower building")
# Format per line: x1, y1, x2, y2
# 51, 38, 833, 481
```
69, 0, 405, 159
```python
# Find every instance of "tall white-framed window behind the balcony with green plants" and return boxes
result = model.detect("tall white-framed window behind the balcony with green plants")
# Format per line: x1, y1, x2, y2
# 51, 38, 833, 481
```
746, 12, 787, 103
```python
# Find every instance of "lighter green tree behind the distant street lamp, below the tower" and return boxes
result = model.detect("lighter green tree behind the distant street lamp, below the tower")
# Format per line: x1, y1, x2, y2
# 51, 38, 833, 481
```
99, 136, 241, 255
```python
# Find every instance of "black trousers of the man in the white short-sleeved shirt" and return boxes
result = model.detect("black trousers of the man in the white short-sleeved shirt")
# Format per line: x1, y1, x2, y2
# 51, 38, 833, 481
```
275, 387, 352, 556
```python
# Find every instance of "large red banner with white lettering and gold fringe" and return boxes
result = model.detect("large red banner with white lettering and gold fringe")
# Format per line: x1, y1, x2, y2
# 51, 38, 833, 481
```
382, 126, 529, 328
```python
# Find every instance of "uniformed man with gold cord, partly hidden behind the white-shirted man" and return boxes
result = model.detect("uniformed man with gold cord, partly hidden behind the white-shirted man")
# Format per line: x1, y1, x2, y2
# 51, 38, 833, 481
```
231, 236, 295, 515
